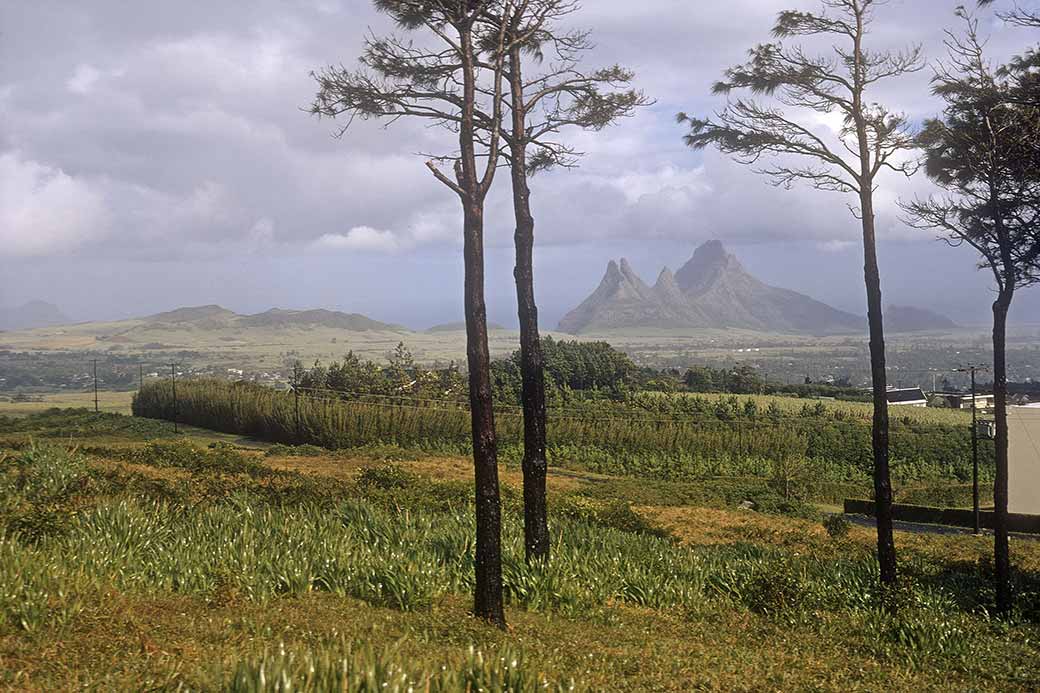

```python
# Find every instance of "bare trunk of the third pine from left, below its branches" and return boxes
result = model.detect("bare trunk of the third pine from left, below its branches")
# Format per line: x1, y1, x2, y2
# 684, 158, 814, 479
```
860, 191, 896, 585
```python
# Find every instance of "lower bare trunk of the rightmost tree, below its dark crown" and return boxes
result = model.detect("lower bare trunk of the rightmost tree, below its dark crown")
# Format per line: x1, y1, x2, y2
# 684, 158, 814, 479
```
993, 287, 1014, 614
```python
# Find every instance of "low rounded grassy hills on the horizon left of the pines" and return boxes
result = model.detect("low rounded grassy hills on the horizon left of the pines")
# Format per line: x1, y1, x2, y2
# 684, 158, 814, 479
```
141, 305, 408, 332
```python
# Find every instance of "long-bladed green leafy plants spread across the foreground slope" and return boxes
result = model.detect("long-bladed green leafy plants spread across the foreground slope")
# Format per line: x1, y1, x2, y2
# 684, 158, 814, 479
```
0, 439, 1038, 691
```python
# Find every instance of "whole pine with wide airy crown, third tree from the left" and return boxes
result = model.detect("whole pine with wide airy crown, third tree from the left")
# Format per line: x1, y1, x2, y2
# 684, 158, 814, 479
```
679, 0, 924, 586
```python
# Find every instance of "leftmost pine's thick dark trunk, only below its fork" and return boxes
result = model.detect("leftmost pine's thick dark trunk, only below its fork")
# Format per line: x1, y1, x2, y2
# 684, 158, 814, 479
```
464, 203, 505, 626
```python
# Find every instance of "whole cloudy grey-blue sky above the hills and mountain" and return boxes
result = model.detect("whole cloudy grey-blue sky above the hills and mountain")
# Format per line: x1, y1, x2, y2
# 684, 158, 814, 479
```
0, 0, 1040, 328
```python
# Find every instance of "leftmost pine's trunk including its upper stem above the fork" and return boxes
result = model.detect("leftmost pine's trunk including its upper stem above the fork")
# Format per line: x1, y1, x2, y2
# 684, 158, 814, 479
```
456, 24, 505, 627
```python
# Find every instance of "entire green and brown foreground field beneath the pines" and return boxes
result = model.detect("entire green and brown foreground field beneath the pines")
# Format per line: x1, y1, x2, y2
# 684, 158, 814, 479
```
0, 412, 1040, 692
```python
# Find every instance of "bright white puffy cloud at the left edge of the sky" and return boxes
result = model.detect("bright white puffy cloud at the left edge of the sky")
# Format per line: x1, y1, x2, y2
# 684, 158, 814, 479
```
0, 153, 108, 256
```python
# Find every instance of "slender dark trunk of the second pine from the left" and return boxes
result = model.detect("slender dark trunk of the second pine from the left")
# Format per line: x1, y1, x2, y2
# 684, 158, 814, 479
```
510, 46, 549, 563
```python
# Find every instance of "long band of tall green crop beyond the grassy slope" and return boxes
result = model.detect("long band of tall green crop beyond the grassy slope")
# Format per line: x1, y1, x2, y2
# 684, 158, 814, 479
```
134, 381, 992, 505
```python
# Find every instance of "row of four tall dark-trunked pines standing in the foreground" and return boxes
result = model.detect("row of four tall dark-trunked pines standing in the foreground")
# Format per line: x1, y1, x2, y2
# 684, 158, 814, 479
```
311, 0, 1040, 626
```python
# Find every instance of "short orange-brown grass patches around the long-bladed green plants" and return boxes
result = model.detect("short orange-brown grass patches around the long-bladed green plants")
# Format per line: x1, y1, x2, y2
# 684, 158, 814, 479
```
0, 409, 1040, 691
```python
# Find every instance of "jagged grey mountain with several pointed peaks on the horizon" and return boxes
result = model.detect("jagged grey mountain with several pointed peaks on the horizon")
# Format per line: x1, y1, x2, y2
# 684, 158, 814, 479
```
560, 240, 865, 334
